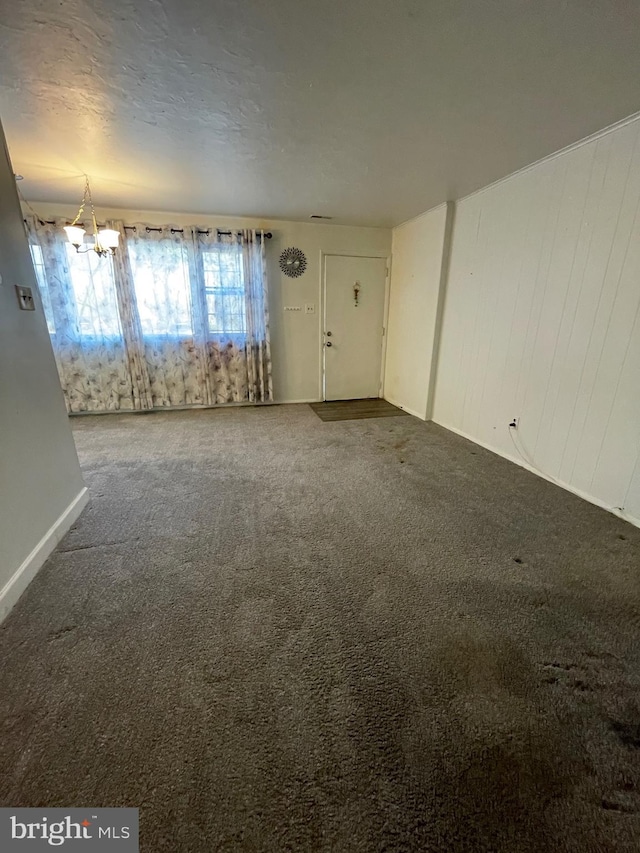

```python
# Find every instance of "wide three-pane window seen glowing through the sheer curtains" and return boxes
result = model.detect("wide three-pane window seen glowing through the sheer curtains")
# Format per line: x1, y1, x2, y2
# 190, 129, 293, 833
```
31, 233, 247, 346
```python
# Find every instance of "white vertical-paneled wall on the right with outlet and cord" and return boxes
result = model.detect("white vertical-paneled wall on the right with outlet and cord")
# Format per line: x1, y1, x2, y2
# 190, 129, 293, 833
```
434, 113, 640, 523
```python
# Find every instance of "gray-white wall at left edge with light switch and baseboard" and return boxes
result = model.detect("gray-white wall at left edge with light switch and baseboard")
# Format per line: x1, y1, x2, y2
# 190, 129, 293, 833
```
0, 127, 86, 620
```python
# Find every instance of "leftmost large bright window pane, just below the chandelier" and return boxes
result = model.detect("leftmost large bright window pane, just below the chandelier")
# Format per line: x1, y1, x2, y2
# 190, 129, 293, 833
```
66, 243, 122, 338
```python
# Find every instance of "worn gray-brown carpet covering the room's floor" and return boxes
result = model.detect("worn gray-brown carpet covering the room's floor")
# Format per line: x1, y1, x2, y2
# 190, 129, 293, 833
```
0, 406, 640, 853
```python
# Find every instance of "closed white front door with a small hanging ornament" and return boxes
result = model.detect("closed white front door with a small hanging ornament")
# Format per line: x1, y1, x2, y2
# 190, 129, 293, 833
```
322, 255, 387, 400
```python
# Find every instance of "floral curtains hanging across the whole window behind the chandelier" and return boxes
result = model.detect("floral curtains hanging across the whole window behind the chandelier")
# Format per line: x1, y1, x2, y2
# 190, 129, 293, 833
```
28, 219, 273, 412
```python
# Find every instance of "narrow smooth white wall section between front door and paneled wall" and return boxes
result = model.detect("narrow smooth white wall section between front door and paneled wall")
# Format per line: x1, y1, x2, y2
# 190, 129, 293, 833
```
384, 204, 450, 420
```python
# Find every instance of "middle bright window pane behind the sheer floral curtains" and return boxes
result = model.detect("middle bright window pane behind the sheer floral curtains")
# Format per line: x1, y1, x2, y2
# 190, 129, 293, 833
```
129, 240, 193, 338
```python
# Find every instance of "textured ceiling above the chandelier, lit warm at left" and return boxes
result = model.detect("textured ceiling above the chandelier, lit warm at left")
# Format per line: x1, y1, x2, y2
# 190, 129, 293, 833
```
0, 0, 640, 225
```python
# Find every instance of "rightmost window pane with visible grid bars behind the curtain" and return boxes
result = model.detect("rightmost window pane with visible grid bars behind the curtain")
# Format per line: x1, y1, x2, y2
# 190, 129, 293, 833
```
202, 246, 246, 335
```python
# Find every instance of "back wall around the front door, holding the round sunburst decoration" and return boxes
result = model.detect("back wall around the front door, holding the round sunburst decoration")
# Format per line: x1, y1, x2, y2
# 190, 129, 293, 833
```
31, 206, 391, 403
